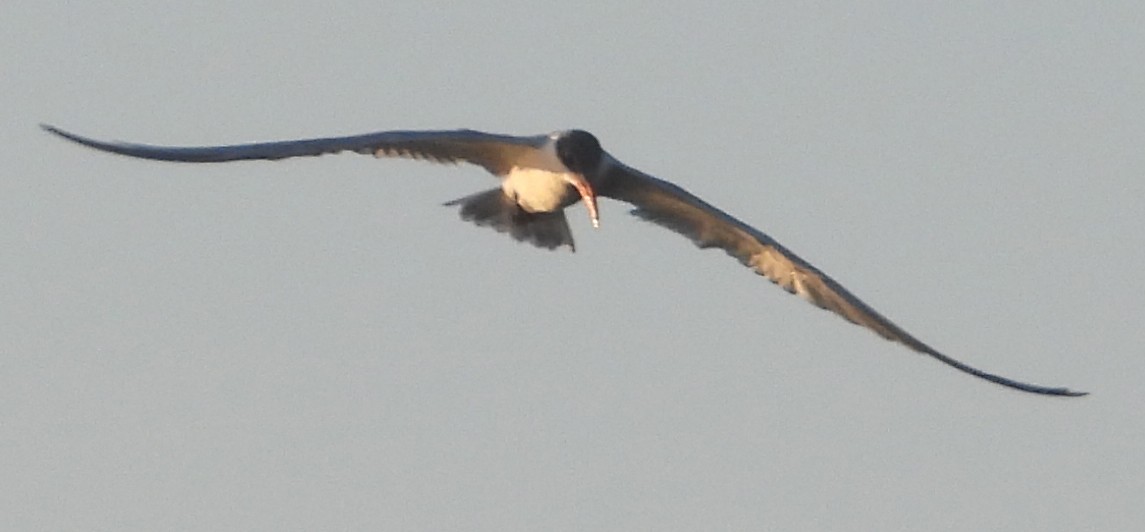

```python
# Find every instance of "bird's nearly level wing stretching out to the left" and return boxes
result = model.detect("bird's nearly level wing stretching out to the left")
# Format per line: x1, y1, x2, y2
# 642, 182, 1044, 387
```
40, 125, 547, 175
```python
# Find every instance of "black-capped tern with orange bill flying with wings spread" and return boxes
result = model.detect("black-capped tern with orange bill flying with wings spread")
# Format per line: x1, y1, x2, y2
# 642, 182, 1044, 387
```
41, 125, 1087, 396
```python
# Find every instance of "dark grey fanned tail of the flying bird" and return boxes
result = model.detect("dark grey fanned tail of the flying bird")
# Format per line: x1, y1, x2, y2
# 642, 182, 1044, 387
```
445, 189, 576, 252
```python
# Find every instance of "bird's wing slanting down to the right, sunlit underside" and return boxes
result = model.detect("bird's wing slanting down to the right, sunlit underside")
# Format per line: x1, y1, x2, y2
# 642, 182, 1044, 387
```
598, 159, 1085, 396
